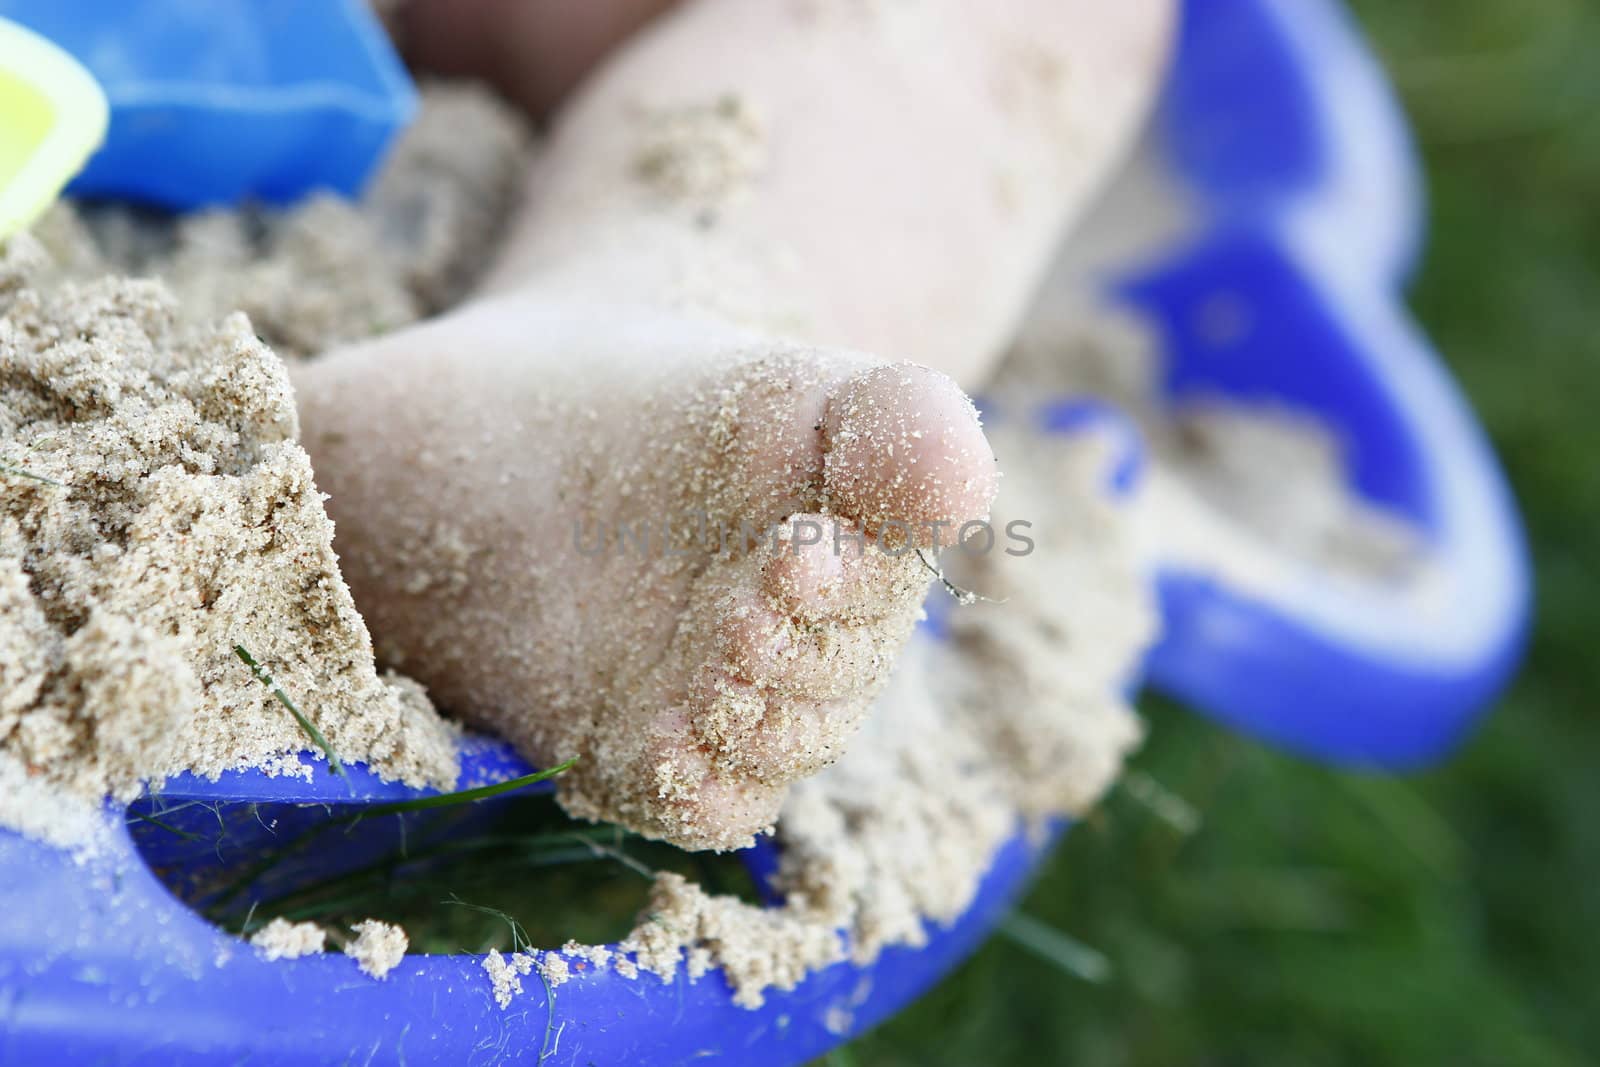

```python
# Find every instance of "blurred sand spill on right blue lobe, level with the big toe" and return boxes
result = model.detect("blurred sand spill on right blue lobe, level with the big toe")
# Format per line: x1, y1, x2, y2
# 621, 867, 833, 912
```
990, 289, 1427, 587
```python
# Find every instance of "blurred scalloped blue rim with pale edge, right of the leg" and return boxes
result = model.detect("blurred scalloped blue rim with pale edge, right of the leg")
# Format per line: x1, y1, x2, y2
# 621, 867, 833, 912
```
1118, 0, 1531, 768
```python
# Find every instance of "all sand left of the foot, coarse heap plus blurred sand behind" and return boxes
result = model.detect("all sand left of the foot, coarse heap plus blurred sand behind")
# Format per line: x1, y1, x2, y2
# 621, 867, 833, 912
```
0, 85, 531, 848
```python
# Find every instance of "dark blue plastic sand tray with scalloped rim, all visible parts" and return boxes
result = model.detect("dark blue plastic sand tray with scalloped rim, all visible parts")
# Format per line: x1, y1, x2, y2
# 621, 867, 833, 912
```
0, 0, 1528, 1067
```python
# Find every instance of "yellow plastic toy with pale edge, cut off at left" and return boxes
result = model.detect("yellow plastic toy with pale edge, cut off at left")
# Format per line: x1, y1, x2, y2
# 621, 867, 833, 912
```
0, 19, 110, 240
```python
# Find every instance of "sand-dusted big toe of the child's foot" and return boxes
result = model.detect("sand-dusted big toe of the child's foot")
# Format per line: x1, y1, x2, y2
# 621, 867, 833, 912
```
822, 363, 1000, 544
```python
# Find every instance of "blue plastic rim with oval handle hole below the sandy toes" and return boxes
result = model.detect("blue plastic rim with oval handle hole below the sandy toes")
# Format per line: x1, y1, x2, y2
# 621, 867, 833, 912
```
9, 742, 1048, 1067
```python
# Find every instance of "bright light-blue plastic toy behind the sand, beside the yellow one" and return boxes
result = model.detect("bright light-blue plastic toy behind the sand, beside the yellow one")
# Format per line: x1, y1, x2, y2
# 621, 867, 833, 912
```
0, 0, 416, 210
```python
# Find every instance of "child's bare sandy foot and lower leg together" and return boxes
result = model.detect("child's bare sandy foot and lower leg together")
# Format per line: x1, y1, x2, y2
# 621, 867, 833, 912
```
296, 0, 1168, 848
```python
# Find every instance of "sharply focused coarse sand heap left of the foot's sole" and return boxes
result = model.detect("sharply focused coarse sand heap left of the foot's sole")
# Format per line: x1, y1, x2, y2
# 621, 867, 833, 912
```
0, 237, 456, 840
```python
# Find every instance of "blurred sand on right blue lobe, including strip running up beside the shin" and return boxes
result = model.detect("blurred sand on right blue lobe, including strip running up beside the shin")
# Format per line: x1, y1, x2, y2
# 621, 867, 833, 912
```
986, 131, 1434, 593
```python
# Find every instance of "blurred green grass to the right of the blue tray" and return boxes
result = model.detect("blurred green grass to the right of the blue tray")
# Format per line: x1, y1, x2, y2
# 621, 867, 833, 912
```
829, 0, 1600, 1067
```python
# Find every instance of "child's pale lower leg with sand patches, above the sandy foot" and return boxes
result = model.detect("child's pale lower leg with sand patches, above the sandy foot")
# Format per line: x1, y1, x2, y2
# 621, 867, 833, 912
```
486, 0, 1173, 389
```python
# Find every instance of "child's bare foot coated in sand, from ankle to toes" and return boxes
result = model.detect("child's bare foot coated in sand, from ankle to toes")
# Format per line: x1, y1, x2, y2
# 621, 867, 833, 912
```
296, 296, 997, 848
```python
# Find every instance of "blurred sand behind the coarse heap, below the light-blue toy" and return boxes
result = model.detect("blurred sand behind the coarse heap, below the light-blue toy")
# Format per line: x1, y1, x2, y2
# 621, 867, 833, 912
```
34, 83, 533, 358
